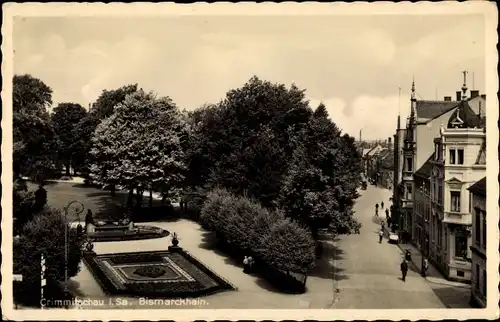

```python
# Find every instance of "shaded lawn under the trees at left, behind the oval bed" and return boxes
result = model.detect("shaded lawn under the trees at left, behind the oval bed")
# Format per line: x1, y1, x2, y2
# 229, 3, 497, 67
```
28, 182, 161, 221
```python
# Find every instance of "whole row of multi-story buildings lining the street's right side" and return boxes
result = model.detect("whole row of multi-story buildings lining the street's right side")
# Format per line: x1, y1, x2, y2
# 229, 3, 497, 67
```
391, 77, 486, 306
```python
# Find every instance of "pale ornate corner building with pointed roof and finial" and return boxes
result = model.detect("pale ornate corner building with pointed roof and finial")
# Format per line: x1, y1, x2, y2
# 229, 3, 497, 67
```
426, 84, 486, 281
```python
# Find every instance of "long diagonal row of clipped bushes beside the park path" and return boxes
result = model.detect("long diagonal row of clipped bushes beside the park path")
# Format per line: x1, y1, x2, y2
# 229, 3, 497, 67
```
200, 189, 315, 274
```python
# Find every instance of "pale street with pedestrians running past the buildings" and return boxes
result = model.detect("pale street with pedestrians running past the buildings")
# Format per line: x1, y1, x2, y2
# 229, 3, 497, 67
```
334, 185, 446, 309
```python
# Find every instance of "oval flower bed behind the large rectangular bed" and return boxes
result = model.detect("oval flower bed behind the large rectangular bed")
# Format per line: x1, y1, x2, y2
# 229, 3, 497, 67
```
88, 225, 170, 242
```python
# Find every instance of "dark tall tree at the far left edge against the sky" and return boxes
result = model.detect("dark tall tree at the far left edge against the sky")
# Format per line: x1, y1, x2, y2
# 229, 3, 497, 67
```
13, 75, 59, 181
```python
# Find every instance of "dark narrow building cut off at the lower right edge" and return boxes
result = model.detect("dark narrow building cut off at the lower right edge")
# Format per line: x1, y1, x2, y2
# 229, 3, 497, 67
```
469, 177, 487, 308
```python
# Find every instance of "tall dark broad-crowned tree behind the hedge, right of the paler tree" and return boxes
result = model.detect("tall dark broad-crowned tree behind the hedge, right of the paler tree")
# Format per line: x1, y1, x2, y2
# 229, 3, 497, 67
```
189, 77, 312, 207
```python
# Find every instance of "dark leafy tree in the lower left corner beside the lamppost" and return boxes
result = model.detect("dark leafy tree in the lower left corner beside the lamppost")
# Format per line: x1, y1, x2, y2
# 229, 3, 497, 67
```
13, 207, 81, 305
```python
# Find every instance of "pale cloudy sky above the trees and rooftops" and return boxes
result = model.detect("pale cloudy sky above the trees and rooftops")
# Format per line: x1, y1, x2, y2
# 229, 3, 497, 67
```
13, 15, 485, 139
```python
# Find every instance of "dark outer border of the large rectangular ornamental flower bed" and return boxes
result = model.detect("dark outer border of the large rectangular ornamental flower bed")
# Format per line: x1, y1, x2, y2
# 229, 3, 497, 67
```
83, 249, 236, 298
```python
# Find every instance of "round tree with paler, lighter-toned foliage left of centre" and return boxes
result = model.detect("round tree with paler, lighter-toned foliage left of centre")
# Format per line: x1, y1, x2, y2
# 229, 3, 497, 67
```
91, 90, 186, 208
